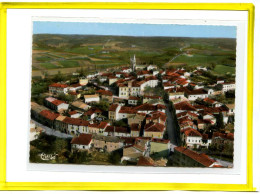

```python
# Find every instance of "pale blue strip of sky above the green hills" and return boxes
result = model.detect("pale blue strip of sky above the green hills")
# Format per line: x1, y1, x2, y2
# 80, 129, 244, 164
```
33, 21, 236, 38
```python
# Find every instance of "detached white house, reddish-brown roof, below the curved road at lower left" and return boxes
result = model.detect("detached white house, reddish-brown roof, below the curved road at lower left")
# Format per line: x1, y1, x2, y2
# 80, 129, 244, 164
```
70, 134, 92, 151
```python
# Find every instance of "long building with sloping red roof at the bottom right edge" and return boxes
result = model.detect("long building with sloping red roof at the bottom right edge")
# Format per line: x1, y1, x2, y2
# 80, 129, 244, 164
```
173, 147, 219, 167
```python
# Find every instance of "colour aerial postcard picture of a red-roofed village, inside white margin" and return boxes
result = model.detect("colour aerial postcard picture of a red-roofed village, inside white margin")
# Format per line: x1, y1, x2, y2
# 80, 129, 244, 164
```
28, 21, 236, 168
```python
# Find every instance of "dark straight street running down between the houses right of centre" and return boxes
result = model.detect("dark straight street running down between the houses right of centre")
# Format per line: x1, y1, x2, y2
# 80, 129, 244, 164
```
165, 103, 177, 146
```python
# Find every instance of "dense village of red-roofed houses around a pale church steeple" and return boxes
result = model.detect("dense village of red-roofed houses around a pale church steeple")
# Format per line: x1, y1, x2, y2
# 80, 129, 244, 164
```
30, 56, 236, 168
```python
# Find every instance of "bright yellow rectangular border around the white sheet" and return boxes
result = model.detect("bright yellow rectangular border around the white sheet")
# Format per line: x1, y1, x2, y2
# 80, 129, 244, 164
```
0, 2, 255, 191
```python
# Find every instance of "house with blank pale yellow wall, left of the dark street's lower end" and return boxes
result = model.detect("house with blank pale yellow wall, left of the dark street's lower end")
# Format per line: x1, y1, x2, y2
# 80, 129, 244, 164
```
150, 138, 170, 158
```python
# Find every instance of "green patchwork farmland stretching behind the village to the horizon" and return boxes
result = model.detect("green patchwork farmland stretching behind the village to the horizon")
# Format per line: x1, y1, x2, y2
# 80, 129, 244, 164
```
32, 34, 236, 76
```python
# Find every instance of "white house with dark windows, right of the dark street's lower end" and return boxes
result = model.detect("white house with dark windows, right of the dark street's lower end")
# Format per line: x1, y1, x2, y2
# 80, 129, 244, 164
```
182, 128, 202, 148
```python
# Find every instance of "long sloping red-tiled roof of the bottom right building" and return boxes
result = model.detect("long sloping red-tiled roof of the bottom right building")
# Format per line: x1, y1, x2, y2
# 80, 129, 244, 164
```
174, 147, 215, 167
